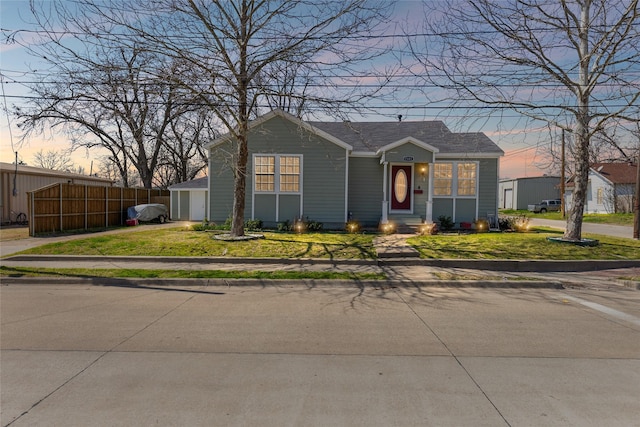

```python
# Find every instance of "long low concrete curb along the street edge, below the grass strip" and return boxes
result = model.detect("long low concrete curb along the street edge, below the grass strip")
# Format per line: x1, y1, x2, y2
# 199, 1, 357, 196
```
2, 277, 564, 290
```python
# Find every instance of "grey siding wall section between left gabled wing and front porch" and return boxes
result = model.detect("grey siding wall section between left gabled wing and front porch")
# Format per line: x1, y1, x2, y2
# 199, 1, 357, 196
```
349, 157, 383, 227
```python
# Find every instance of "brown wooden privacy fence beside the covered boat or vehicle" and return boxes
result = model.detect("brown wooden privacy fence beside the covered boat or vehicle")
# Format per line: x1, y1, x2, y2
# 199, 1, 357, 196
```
27, 183, 169, 236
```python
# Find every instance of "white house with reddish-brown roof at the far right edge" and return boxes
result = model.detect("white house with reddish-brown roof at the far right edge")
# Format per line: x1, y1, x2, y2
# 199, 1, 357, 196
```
565, 163, 638, 213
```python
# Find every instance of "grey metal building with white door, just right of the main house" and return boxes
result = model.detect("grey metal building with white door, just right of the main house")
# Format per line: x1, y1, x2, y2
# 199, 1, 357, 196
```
498, 175, 560, 210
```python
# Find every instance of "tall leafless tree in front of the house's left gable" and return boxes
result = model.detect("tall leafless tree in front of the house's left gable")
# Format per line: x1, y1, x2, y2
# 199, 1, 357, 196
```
67, 0, 388, 236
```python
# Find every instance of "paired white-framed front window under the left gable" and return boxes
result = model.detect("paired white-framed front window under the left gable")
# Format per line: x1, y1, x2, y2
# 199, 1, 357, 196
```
254, 155, 301, 193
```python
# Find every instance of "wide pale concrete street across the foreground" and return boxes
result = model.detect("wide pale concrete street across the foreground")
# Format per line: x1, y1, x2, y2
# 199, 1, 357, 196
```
0, 282, 640, 426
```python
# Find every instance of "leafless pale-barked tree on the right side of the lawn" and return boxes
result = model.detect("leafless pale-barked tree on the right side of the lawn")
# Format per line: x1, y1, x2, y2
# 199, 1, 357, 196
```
411, 0, 640, 240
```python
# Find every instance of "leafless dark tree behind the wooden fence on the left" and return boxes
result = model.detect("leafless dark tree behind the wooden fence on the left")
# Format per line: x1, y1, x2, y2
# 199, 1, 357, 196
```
18, 1, 212, 188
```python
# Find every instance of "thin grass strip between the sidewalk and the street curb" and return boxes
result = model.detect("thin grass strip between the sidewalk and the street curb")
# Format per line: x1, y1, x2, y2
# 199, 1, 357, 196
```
0, 266, 386, 280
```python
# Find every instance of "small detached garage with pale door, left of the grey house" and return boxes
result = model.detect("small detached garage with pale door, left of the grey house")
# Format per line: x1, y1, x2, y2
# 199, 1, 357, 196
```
169, 176, 209, 221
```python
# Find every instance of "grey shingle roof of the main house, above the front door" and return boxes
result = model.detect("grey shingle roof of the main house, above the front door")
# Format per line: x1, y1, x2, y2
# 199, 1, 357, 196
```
308, 121, 504, 154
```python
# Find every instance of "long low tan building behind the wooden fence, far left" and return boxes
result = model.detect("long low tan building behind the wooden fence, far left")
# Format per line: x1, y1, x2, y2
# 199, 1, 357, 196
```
0, 162, 113, 223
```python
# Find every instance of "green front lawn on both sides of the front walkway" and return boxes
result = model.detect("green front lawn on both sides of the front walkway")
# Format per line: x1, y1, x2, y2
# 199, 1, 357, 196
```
15, 224, 640, 260
